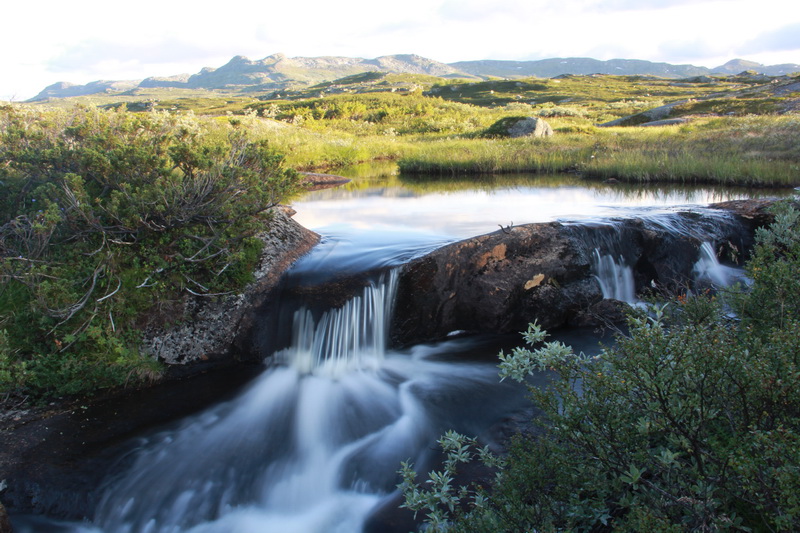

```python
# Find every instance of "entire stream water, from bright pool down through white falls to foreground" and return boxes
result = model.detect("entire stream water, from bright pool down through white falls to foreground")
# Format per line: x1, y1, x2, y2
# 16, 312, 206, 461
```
18, 172, 788, 533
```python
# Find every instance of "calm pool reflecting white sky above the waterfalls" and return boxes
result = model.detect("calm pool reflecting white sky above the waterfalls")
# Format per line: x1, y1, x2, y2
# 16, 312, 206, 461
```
293, 171, 780, 270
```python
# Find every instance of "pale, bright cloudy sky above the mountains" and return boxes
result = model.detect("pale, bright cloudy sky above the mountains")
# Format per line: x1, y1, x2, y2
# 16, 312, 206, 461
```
0, 0, 800, 101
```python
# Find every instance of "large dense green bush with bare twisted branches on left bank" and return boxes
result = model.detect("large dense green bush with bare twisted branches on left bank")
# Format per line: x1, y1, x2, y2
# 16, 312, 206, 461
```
0, 106, 298, 394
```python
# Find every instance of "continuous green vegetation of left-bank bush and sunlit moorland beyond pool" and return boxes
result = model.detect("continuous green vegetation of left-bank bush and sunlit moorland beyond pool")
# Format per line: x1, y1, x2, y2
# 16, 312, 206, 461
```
0, 69, 800, 394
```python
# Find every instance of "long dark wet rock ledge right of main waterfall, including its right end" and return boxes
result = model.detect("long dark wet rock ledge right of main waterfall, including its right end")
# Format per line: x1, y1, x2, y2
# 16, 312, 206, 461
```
392, 211, 764, 345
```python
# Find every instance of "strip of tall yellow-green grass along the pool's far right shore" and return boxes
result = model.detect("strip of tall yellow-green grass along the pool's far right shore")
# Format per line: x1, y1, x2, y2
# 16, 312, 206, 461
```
399, 116, 800, 187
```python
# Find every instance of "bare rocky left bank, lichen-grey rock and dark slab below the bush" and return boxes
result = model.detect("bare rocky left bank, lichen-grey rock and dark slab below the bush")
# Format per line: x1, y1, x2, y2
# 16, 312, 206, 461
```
0, 206, 319, 519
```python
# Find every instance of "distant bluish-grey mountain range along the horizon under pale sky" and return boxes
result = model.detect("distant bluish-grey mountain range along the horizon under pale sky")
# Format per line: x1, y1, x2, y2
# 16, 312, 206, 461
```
30, 54, 800, 101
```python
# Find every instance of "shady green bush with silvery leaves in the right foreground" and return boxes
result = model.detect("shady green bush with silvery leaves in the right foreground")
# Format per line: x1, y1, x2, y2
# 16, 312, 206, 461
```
403, 200, 800, 532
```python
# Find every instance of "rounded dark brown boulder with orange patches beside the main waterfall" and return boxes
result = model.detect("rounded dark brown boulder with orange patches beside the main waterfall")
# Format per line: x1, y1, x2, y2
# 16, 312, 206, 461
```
392, 223, 601, 344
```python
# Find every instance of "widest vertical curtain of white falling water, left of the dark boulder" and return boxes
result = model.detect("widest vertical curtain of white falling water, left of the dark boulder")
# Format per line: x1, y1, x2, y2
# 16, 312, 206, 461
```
279, 268, 399, 376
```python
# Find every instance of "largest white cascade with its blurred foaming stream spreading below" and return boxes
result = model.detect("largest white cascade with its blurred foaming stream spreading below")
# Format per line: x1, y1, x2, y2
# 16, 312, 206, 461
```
61, 271, 521, 533
